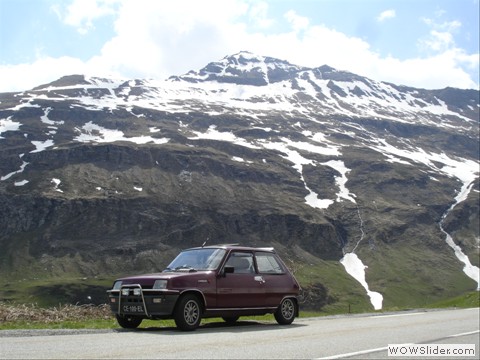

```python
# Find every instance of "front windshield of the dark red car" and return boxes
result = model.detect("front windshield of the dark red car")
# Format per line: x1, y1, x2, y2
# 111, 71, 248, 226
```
164, 248, 225, 271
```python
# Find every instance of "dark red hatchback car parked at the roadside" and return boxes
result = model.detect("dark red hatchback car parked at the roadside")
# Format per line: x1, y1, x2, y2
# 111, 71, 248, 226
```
108, 245, 300, 331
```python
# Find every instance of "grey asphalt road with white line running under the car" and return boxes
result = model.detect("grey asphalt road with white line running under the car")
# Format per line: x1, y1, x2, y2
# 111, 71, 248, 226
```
0, 308, 480, 359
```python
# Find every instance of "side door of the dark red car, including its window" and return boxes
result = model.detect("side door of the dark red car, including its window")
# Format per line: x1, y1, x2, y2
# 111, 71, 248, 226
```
217, 251, 265, 308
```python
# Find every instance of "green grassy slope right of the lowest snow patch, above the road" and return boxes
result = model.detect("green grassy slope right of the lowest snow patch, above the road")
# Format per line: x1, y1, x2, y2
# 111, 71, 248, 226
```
350, 239, 477, 310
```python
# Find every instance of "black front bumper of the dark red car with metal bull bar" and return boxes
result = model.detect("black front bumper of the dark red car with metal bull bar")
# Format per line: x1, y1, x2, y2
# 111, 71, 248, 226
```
107, 284, 180, 319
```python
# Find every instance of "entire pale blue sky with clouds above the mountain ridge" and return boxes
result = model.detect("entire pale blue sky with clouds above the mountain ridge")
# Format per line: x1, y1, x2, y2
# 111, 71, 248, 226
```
0, 0, 479, 92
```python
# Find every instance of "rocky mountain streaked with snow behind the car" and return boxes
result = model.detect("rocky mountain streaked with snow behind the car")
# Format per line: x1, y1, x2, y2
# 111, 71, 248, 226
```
0, 52, 480, 309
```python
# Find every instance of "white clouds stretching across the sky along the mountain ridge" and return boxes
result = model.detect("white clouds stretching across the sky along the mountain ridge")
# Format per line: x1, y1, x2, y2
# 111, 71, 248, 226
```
0, 0, 478, 91
